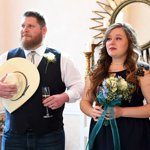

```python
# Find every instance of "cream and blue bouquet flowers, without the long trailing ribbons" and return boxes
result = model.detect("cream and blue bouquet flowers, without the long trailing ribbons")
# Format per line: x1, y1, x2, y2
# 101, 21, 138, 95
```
97, 76, 134, 126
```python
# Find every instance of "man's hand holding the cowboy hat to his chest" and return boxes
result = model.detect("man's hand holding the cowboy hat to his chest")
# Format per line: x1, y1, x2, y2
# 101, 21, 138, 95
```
0, 74, 17, 99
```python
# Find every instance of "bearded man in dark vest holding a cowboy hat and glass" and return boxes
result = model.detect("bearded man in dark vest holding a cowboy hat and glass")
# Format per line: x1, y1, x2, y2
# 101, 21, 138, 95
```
0, 11, 83, 150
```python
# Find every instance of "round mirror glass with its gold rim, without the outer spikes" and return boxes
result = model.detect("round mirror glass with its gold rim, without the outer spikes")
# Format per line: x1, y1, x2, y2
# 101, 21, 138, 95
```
110, 0, 150, 50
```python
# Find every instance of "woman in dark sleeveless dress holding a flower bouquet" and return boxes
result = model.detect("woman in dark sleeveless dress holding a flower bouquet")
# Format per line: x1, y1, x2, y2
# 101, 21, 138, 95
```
80, 23, 150, 150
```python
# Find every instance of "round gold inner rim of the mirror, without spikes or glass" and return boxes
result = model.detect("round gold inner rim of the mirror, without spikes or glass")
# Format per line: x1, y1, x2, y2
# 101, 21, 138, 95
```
110, 0, 150, 50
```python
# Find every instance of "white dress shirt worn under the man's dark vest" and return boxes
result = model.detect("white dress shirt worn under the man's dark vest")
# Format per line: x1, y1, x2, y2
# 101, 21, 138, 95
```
0, 45, 84, 103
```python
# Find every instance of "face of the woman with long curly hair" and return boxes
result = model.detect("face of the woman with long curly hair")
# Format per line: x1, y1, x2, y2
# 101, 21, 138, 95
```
106, 28, 129, 58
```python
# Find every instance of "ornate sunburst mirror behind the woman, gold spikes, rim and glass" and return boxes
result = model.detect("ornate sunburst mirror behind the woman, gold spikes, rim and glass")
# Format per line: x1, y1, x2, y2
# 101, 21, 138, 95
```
90, 0, 150, 63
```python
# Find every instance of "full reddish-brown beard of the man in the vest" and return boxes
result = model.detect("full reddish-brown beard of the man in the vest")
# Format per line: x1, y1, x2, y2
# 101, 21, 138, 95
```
21, 34, 43, 50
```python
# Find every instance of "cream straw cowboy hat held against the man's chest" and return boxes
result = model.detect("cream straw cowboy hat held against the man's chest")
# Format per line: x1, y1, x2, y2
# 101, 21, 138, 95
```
0, 57, 40, 113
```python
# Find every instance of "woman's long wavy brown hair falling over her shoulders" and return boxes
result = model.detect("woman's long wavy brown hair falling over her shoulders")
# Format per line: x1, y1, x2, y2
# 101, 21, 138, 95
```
88, 23, 139, 100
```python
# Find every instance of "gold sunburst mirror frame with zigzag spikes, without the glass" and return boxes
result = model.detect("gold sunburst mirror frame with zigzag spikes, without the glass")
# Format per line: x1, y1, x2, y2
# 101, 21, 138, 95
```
90, 0, 150, 50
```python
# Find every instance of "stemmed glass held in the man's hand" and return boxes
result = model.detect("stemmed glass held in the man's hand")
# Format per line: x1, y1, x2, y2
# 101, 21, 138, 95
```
42, 86, 53, 118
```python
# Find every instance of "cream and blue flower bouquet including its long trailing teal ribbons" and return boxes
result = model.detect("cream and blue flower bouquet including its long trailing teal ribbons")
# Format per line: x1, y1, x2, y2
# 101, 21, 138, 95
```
86, 76, 135, 150
